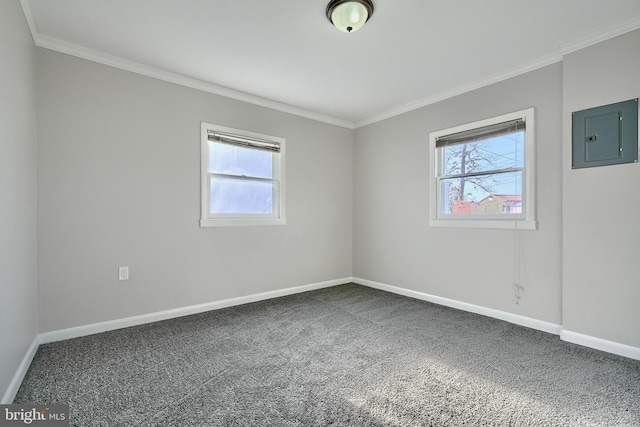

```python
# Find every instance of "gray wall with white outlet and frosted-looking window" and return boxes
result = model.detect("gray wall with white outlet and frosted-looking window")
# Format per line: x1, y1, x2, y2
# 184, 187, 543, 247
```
37, 49, 353, 332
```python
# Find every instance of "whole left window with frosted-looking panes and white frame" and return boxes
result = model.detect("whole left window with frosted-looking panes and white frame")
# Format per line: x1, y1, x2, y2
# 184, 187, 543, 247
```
200, 123, 285, 227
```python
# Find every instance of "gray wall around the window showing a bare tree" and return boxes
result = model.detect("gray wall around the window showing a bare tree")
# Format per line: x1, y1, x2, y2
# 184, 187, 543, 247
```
353, 63, 562, 324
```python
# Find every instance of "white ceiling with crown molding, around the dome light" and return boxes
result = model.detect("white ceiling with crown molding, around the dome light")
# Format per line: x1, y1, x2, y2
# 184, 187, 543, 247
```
22, 0, 640, 127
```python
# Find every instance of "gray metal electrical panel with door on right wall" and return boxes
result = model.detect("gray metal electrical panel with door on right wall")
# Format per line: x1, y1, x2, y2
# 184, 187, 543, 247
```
572, 98, 638, 169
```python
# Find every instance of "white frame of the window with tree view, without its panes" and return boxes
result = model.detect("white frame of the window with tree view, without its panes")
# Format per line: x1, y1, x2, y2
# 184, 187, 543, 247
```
429, 108, 538, 230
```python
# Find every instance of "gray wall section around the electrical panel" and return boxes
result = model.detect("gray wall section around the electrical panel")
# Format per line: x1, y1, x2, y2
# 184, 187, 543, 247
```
562, 30, 640, 347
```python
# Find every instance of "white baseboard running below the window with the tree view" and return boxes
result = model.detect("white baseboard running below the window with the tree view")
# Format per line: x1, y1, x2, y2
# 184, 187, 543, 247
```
353, 277, 562, 335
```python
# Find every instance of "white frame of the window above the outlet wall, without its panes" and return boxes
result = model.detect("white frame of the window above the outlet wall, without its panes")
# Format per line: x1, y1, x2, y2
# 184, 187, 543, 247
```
200, 122, 286, 227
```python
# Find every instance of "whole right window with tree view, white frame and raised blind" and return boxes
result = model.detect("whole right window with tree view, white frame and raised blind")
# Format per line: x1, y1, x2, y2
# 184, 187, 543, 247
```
429, 108, 537, 229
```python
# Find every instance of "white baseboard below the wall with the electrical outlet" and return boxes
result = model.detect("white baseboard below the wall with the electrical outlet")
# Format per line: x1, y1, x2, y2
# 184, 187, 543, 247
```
40, 277, 352, 344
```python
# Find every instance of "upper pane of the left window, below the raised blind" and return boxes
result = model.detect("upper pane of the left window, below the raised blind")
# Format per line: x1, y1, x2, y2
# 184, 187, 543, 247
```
209, 141, 273, 179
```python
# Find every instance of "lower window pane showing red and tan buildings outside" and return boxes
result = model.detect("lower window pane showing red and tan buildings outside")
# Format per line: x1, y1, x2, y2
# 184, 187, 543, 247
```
440, 171, 522, 215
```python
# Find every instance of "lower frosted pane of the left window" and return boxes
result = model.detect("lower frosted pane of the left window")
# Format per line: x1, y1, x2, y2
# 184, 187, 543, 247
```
210, 176, 277, 214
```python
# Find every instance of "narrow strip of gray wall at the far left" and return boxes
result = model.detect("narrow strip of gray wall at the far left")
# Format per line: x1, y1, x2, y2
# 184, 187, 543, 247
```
0, 0, 38, 399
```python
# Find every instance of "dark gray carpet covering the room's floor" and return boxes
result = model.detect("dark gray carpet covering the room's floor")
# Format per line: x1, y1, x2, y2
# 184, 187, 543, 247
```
15, 284, 640, 427
